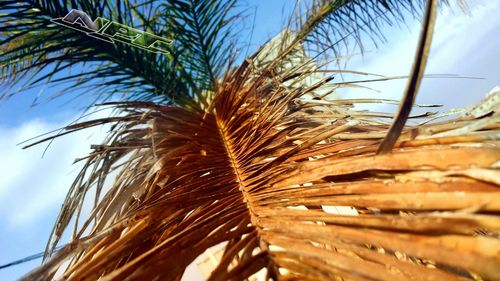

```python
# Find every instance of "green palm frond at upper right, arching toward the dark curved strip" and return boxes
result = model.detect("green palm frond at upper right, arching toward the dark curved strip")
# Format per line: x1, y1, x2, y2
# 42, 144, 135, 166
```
293, 0, 467, 57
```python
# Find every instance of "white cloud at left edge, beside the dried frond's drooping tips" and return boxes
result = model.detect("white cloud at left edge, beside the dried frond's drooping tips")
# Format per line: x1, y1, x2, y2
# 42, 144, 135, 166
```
0, 111, 110, 229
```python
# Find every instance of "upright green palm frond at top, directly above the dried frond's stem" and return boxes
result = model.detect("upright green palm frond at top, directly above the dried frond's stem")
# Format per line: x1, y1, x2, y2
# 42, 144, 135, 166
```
161, 0, 241, 90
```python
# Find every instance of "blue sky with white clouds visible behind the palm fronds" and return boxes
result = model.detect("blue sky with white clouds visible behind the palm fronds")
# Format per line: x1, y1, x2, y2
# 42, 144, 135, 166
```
0, 0, 500, 280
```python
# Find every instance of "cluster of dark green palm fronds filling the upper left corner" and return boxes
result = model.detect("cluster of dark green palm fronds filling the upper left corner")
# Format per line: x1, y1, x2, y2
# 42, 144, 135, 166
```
0, 0, 242, 107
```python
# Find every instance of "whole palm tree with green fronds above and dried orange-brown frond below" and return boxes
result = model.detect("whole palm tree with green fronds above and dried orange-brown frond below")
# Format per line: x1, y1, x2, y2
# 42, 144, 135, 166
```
0, 0, 500, 280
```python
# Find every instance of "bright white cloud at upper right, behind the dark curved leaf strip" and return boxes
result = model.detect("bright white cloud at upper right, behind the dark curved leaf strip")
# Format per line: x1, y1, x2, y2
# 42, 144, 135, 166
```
341, 0, 500, 110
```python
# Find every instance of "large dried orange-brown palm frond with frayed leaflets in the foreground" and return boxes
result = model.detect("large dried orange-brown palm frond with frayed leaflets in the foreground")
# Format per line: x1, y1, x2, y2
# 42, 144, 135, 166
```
19, 31, 500, 280
